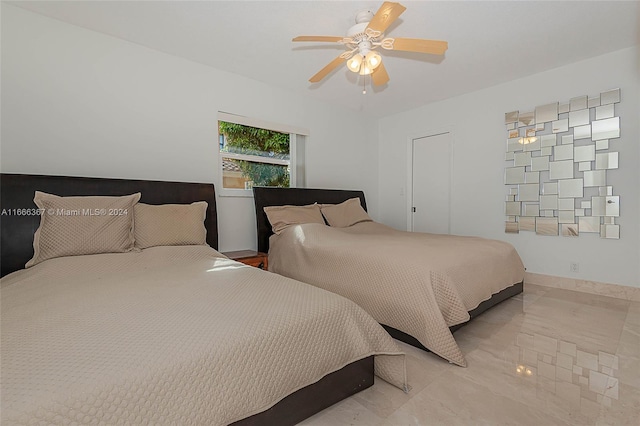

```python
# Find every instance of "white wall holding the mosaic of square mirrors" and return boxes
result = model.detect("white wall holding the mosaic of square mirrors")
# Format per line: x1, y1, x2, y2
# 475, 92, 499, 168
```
378, 48, 640, 287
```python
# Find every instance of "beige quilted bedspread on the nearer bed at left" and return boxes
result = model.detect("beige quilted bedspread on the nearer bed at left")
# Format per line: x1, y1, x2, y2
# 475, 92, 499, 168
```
0, 246, 406, 425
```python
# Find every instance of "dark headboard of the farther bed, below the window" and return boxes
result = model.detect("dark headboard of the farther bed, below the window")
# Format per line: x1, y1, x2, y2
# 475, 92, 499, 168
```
253, 186, 367, 253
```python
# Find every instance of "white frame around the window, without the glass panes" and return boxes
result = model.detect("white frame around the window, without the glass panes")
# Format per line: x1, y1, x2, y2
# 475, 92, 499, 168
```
216, 111, 309, 197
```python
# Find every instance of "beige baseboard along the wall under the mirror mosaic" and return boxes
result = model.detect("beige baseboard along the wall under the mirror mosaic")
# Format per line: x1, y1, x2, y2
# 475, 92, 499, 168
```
524, 272, 640, 302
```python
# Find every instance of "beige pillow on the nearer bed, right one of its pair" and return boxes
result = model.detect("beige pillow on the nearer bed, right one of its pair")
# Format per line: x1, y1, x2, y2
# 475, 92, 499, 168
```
134, 201, 208, 249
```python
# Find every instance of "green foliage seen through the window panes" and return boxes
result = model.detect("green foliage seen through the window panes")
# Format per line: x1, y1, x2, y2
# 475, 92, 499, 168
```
219, 121, 290, 187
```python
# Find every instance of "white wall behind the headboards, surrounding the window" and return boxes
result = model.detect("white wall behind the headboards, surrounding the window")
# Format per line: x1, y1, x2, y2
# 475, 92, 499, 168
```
0, 3, 377, 250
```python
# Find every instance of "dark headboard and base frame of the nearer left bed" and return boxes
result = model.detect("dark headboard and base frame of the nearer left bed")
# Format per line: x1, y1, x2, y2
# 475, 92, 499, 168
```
0, 173, 374, 426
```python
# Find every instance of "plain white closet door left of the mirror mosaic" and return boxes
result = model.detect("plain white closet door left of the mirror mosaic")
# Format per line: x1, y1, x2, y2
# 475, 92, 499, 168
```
411, 133, 453, 234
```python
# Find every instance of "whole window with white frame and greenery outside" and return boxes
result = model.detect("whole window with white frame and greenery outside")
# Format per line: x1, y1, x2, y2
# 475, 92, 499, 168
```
218, 113, 307, 196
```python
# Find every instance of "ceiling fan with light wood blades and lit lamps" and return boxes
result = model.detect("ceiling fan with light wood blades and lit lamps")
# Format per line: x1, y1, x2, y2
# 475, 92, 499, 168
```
292, 1, 448, 88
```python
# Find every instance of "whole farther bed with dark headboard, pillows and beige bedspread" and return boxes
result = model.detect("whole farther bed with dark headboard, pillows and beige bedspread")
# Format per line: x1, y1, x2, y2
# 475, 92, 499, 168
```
253, 187, 524, 366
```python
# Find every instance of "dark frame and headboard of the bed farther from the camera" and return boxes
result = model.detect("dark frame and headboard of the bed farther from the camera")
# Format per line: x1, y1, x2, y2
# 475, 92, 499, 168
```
253, 187, 524, 351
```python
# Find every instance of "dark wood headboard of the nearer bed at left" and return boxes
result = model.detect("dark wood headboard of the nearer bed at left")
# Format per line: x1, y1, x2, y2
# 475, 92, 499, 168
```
0, 173, 218, 276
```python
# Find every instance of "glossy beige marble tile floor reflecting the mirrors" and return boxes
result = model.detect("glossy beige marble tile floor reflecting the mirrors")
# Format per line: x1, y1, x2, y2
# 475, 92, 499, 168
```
301, 284, 640, 426
